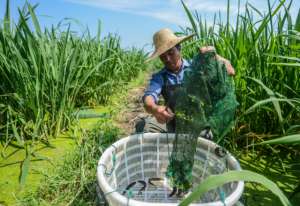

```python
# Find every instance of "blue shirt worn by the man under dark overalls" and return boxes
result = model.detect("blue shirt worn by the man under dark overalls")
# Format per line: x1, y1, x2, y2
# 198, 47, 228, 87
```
143, 59, 190, 103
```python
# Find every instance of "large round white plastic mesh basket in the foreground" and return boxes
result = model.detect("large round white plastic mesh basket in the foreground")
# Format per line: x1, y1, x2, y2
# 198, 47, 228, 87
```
97, 133, 244, 206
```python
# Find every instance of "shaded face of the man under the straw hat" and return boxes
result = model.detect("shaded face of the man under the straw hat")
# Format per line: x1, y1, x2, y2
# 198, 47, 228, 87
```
159, 47, 181, 73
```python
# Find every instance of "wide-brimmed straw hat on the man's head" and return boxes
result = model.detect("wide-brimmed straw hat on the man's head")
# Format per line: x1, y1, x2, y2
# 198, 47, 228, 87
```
146, 28, 194, 62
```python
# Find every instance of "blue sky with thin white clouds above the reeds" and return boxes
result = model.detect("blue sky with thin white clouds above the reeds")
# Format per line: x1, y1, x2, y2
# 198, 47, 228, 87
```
0, 0, 300, 50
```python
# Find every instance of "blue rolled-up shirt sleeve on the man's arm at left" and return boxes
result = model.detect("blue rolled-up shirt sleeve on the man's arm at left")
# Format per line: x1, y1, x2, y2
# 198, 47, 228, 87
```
143, 73, 163, 103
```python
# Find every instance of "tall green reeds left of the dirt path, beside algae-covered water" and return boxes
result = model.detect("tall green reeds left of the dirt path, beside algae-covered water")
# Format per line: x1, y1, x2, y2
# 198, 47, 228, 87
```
0, 0, 145, 186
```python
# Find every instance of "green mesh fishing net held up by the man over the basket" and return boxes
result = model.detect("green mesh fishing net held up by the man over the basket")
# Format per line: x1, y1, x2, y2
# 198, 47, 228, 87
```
166, 51, 238, 191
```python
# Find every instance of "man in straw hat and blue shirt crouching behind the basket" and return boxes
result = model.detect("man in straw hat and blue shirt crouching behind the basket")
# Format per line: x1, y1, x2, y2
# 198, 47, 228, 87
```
136, 28, 234, 132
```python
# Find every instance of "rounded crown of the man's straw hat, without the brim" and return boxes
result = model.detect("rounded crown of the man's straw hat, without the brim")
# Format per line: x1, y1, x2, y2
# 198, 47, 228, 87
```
153, 28, 178, 50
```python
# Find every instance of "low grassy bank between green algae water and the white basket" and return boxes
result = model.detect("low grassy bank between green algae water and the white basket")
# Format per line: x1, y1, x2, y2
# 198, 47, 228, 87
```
19, 119, 119, 206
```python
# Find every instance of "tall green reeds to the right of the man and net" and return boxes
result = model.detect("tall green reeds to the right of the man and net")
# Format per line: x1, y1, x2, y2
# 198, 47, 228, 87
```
181, 0, 300, 139
